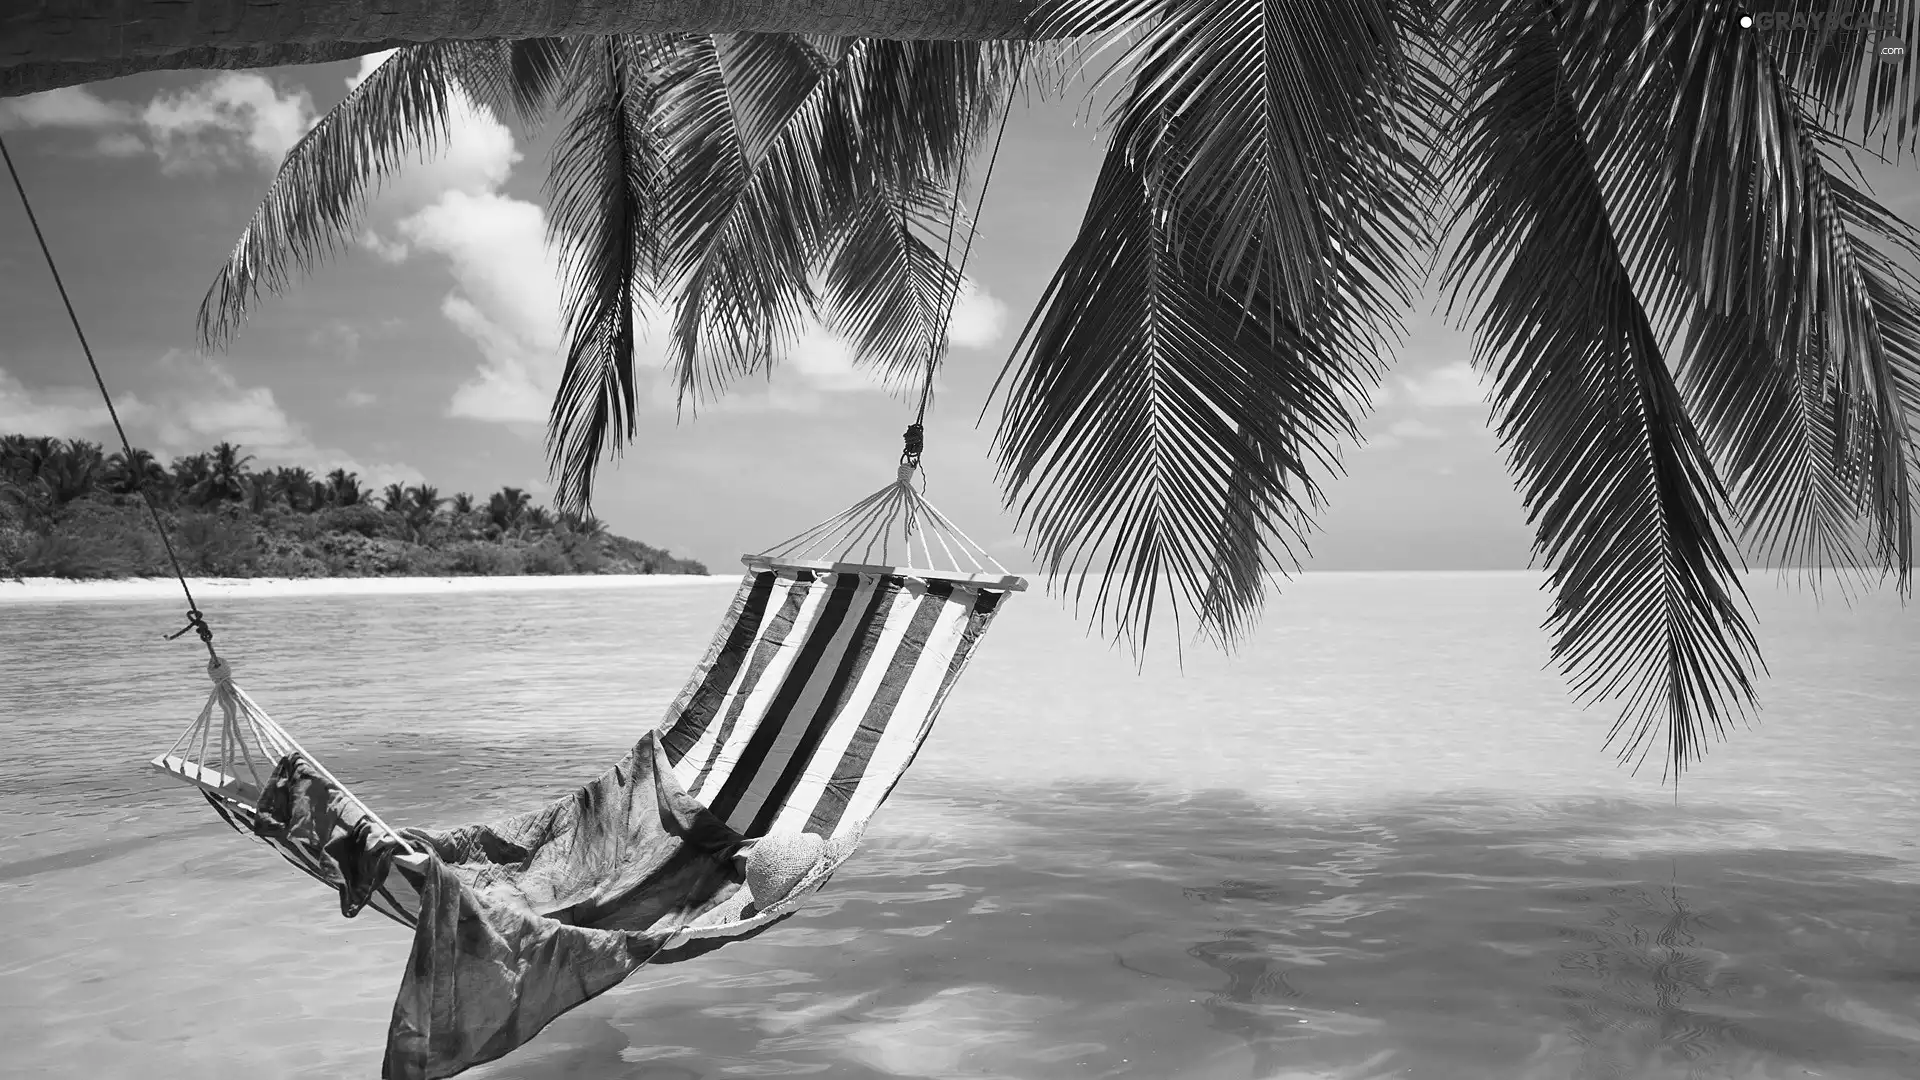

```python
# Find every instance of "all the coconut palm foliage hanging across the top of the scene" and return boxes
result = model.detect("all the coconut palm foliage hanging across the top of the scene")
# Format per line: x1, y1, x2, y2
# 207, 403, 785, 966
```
7, 0, 1920, 771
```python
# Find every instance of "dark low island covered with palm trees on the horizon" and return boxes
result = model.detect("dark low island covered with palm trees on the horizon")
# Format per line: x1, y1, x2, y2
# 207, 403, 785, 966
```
0, 434, 707, 580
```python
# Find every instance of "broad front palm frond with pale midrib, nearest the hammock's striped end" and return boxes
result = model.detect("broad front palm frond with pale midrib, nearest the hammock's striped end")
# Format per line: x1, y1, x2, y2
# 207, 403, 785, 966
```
995, 131, 1359, 644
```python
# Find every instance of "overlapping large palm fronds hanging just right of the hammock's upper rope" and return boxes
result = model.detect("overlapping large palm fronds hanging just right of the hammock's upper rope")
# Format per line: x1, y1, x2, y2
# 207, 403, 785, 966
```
996, 0, 1436, 644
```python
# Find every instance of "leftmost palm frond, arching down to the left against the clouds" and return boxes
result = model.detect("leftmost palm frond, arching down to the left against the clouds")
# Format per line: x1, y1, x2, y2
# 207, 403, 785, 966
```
198, 42, 474, 348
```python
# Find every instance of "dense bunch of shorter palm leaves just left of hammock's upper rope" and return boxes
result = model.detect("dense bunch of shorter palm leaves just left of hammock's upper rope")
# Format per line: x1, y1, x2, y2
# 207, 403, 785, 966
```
660, 35, 1025, 398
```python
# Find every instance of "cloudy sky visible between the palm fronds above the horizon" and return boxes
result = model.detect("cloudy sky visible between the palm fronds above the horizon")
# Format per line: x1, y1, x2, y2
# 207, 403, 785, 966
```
0, 53, 1651, 573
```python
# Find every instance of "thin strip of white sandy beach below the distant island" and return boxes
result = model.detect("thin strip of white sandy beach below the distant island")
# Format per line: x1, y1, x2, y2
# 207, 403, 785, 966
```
0, 575, 739, 605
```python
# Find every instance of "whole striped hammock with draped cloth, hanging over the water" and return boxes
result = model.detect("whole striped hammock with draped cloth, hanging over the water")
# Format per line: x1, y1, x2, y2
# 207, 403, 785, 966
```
152, 463, 1025, 1078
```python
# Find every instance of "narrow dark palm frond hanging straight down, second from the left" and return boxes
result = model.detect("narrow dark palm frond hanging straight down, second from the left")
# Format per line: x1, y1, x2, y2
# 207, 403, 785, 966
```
547, 37, 660, 515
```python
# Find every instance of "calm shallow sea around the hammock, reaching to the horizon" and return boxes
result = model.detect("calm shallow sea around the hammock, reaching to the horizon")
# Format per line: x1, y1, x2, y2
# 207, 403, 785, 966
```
0, 573, 1920, 1080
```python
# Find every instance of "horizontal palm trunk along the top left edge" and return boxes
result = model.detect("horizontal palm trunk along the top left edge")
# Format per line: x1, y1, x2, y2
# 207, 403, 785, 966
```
0, 0, 1039, 96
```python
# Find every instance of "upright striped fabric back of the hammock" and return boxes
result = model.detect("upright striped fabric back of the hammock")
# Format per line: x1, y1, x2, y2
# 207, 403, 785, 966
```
659, 567, 1004, 838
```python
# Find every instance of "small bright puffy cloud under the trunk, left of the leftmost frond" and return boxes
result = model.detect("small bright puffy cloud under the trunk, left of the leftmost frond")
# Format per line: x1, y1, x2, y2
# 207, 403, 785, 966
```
140, 71, 317, 173
